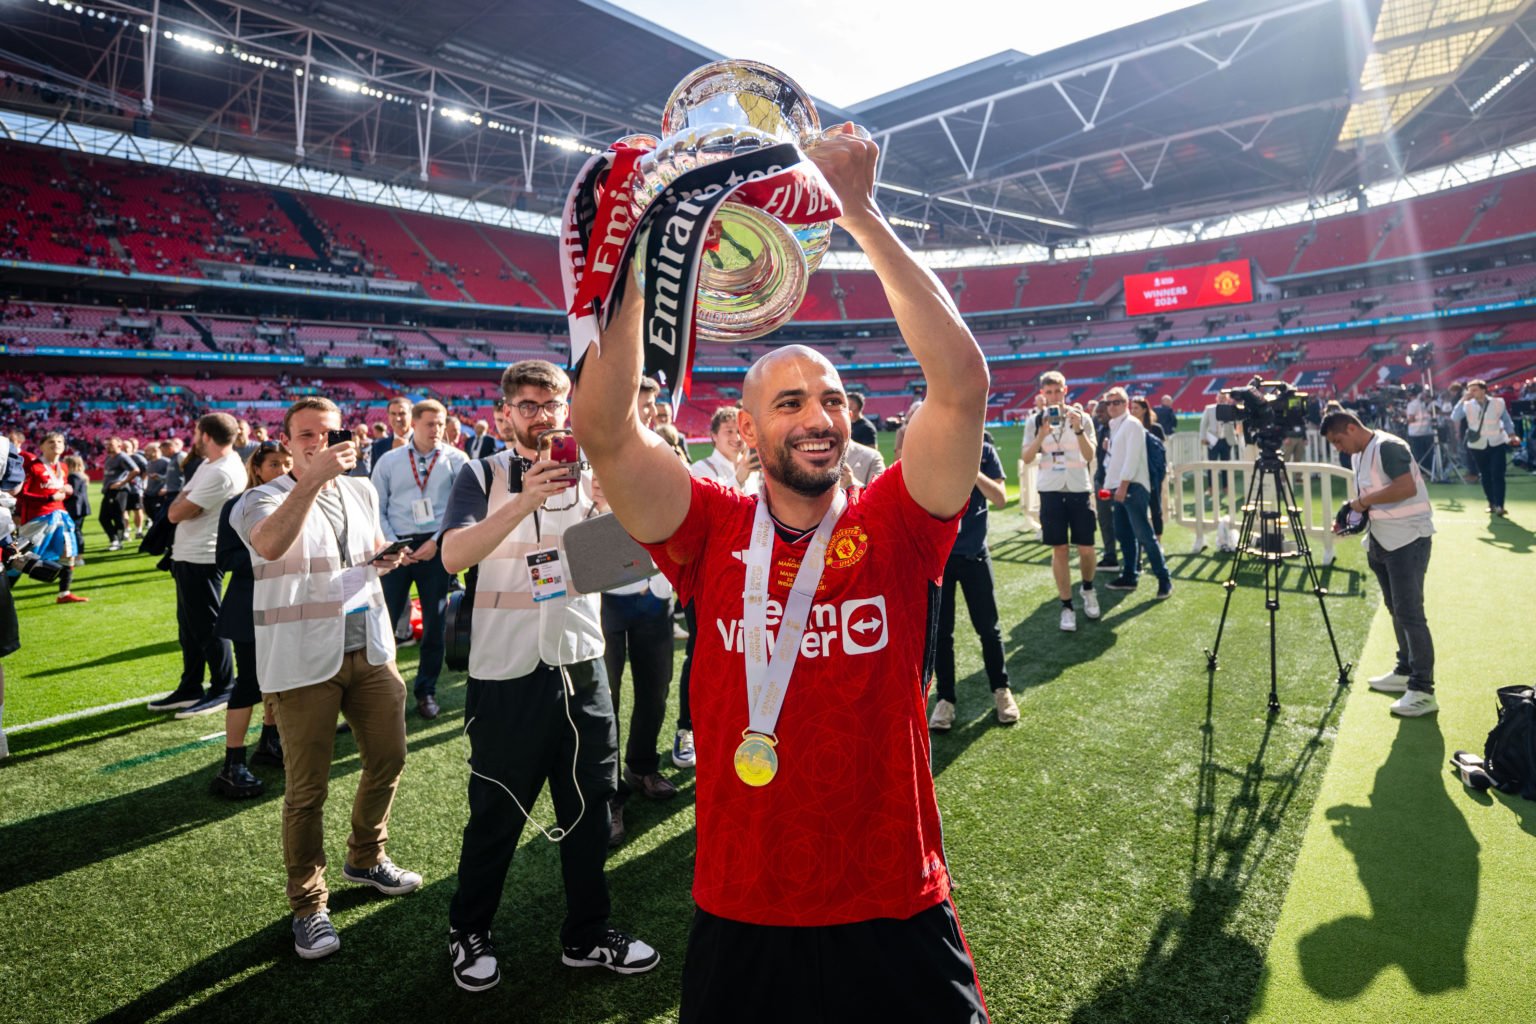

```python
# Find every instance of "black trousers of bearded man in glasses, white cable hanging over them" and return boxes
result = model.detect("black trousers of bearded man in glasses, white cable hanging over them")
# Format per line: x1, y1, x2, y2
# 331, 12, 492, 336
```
449, 659, 619, 946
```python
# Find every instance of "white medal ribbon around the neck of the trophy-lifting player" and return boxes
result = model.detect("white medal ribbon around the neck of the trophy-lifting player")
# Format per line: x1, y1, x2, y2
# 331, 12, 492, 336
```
742, 488, 848, 735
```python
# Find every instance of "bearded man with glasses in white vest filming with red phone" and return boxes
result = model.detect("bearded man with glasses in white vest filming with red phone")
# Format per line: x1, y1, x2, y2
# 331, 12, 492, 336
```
441, 359, 657, 992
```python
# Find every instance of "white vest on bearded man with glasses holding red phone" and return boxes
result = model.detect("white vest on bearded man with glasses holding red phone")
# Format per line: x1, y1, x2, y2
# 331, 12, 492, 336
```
467, 450, 604, 680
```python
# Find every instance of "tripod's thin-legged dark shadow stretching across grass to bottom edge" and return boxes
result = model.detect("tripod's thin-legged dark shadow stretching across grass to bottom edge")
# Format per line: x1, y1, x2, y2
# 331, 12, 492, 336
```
1071, 676, 1347, 1024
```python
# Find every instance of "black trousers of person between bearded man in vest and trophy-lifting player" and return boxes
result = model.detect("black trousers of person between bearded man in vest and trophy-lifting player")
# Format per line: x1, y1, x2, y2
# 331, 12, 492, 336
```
602, 593, 673, 776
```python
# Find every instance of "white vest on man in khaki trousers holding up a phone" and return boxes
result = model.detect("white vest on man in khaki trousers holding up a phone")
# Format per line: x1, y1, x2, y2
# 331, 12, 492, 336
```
250, 476, 395, 692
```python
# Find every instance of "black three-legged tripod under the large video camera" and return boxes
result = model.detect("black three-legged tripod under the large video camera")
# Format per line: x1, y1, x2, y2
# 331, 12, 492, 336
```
1206, 439, 1352, 714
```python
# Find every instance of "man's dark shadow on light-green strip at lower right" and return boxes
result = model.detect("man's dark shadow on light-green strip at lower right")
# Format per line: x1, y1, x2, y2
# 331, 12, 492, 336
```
1298, 718, 1481, 999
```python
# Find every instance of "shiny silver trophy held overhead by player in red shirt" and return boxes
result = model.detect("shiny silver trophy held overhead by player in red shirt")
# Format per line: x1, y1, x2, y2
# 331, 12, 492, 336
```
625, 60, 869, 341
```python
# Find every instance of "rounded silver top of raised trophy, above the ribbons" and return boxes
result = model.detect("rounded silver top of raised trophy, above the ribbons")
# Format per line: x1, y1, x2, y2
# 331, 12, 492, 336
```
662, 60, 822, 143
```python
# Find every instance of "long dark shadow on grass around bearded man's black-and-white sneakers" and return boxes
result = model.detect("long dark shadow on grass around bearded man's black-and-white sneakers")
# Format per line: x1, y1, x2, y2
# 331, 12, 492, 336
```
95, 832, 693, 1024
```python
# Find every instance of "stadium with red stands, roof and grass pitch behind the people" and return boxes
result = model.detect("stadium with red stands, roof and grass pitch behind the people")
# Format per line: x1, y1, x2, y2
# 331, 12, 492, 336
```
0, 0, 1536, 1024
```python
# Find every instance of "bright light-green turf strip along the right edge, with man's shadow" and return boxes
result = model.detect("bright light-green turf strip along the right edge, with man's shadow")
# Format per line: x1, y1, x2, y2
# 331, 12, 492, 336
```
1250, 485, 1536, 1024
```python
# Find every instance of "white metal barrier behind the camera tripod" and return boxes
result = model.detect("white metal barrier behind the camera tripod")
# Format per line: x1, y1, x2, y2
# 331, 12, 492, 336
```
1163, 461, 1355, 565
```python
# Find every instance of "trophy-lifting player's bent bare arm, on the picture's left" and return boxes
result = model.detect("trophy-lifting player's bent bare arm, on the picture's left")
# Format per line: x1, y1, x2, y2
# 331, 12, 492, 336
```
571, 291, 693, 543
